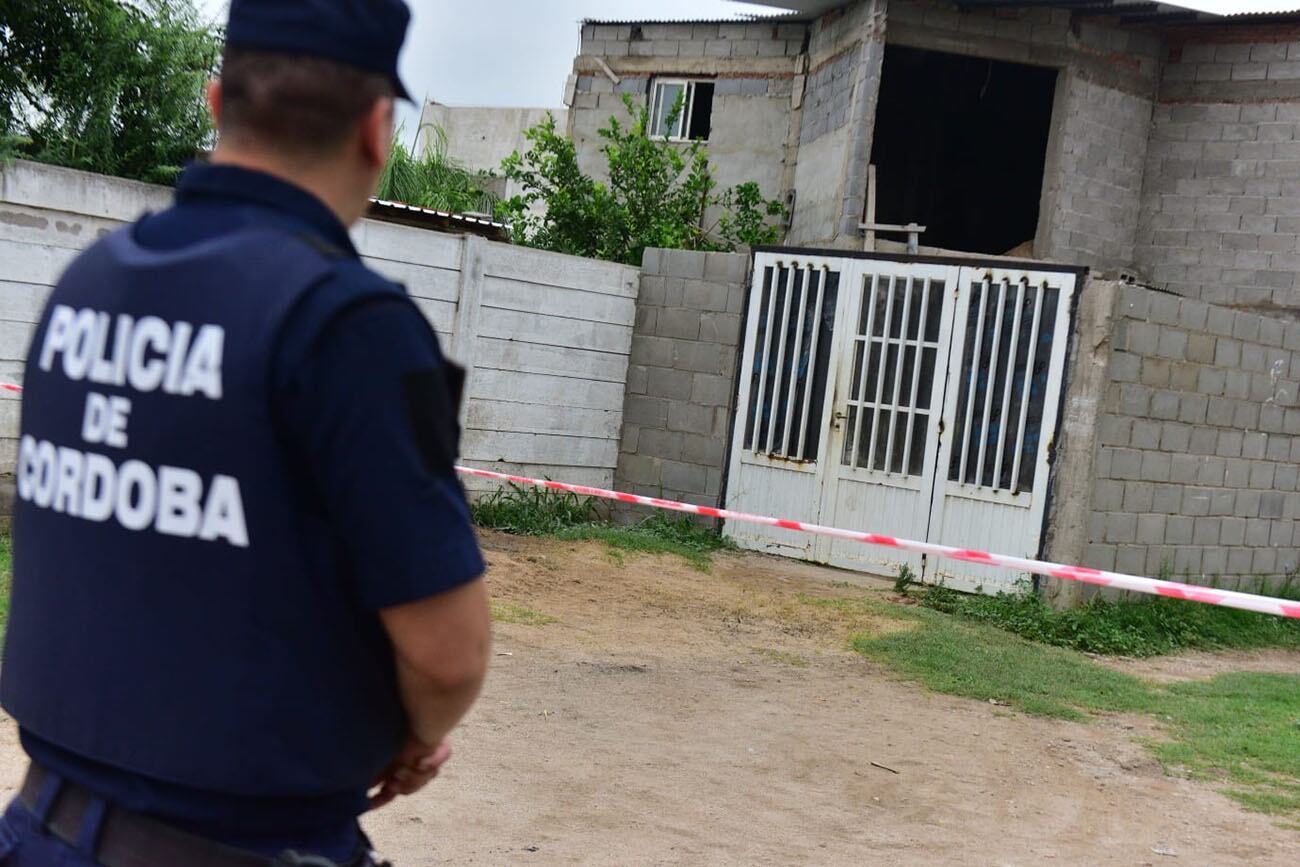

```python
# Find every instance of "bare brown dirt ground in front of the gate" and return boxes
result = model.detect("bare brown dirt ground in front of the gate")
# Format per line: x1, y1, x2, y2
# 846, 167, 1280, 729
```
0, 534, 1300, 867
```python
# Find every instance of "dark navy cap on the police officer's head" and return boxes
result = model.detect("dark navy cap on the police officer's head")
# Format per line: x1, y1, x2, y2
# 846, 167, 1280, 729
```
226, 0, 411, 99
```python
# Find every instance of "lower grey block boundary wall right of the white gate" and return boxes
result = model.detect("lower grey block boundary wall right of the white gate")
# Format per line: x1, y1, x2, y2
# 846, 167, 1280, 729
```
1084, 286, 1300, 586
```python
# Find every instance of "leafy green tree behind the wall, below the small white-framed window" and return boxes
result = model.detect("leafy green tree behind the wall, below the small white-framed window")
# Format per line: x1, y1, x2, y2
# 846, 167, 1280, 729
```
498, 96, 784, 265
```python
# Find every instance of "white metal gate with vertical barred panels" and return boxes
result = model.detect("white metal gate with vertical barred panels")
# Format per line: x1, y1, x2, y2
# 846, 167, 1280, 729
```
727, 251, 1076, 591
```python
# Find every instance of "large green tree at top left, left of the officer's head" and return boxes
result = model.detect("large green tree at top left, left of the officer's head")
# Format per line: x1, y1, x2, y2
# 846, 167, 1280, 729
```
0, 0, 221, 182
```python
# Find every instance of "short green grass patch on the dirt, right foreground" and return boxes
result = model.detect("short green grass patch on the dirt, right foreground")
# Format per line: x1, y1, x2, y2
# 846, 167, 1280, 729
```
847, 590, 1300, 828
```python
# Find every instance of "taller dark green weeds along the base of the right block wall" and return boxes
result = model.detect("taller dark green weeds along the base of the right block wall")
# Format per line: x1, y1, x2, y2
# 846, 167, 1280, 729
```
924, 588, 1300, 656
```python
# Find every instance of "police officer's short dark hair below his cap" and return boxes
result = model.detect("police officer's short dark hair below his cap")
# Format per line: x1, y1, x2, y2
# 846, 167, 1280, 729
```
221, 47, 394, 156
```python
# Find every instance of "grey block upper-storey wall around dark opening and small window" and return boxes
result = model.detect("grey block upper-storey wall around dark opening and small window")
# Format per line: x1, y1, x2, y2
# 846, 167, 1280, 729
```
569, 0, 1162, 259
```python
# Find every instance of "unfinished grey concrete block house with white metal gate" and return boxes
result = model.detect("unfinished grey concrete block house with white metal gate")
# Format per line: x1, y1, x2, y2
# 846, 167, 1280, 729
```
568, 0, 1300, 590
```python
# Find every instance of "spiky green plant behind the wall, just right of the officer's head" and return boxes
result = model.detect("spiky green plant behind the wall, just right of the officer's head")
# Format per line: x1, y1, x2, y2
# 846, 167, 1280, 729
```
376, 123, 497, 214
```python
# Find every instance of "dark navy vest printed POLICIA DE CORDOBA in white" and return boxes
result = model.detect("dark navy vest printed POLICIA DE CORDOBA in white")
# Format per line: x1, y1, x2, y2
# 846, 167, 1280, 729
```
0, 229, 406, 796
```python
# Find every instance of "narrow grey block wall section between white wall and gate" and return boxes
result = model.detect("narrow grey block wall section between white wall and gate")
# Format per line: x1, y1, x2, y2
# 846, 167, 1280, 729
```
615, 250, 749, 506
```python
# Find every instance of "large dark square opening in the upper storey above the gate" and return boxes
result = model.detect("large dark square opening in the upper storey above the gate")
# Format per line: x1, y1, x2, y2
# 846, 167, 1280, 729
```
871, 45, 1057, 256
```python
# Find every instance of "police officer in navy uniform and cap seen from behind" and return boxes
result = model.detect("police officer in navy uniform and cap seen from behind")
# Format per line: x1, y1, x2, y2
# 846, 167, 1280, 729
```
0, 0, 489, 867
